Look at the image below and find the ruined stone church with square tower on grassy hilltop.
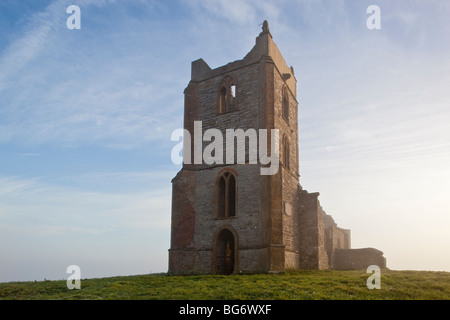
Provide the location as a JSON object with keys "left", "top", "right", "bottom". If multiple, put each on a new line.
{"left": 169, "top": 21, "right": 385, "bottom": 274}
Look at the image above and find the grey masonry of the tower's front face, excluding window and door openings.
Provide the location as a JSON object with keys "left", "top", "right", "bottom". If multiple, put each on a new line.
{"left": 186, "top": 58, "right": 270, "bottom": 273}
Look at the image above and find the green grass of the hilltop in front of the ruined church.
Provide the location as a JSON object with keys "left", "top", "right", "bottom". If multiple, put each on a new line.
{"left": 0, "top": 270, "right": 450, "bottom": 300}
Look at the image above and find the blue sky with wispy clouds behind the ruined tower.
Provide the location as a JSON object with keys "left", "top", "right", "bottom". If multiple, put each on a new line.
{"left": 0, "top": 0, "right": 450, "bottom": 281}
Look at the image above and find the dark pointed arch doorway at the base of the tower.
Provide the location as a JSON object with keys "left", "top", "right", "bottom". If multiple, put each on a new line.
{"left": 213, "top": 228, "right": 237, "bottom": 275}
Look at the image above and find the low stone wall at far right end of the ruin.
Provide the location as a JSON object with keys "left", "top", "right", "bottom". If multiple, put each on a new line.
{"left": 333, "top": 248, "right": 386, "bottom": 270}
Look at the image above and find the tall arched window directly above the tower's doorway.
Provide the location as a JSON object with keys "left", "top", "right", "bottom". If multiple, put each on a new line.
{"left": 216, "top": 171, "right": 237, "bottom": 218}
